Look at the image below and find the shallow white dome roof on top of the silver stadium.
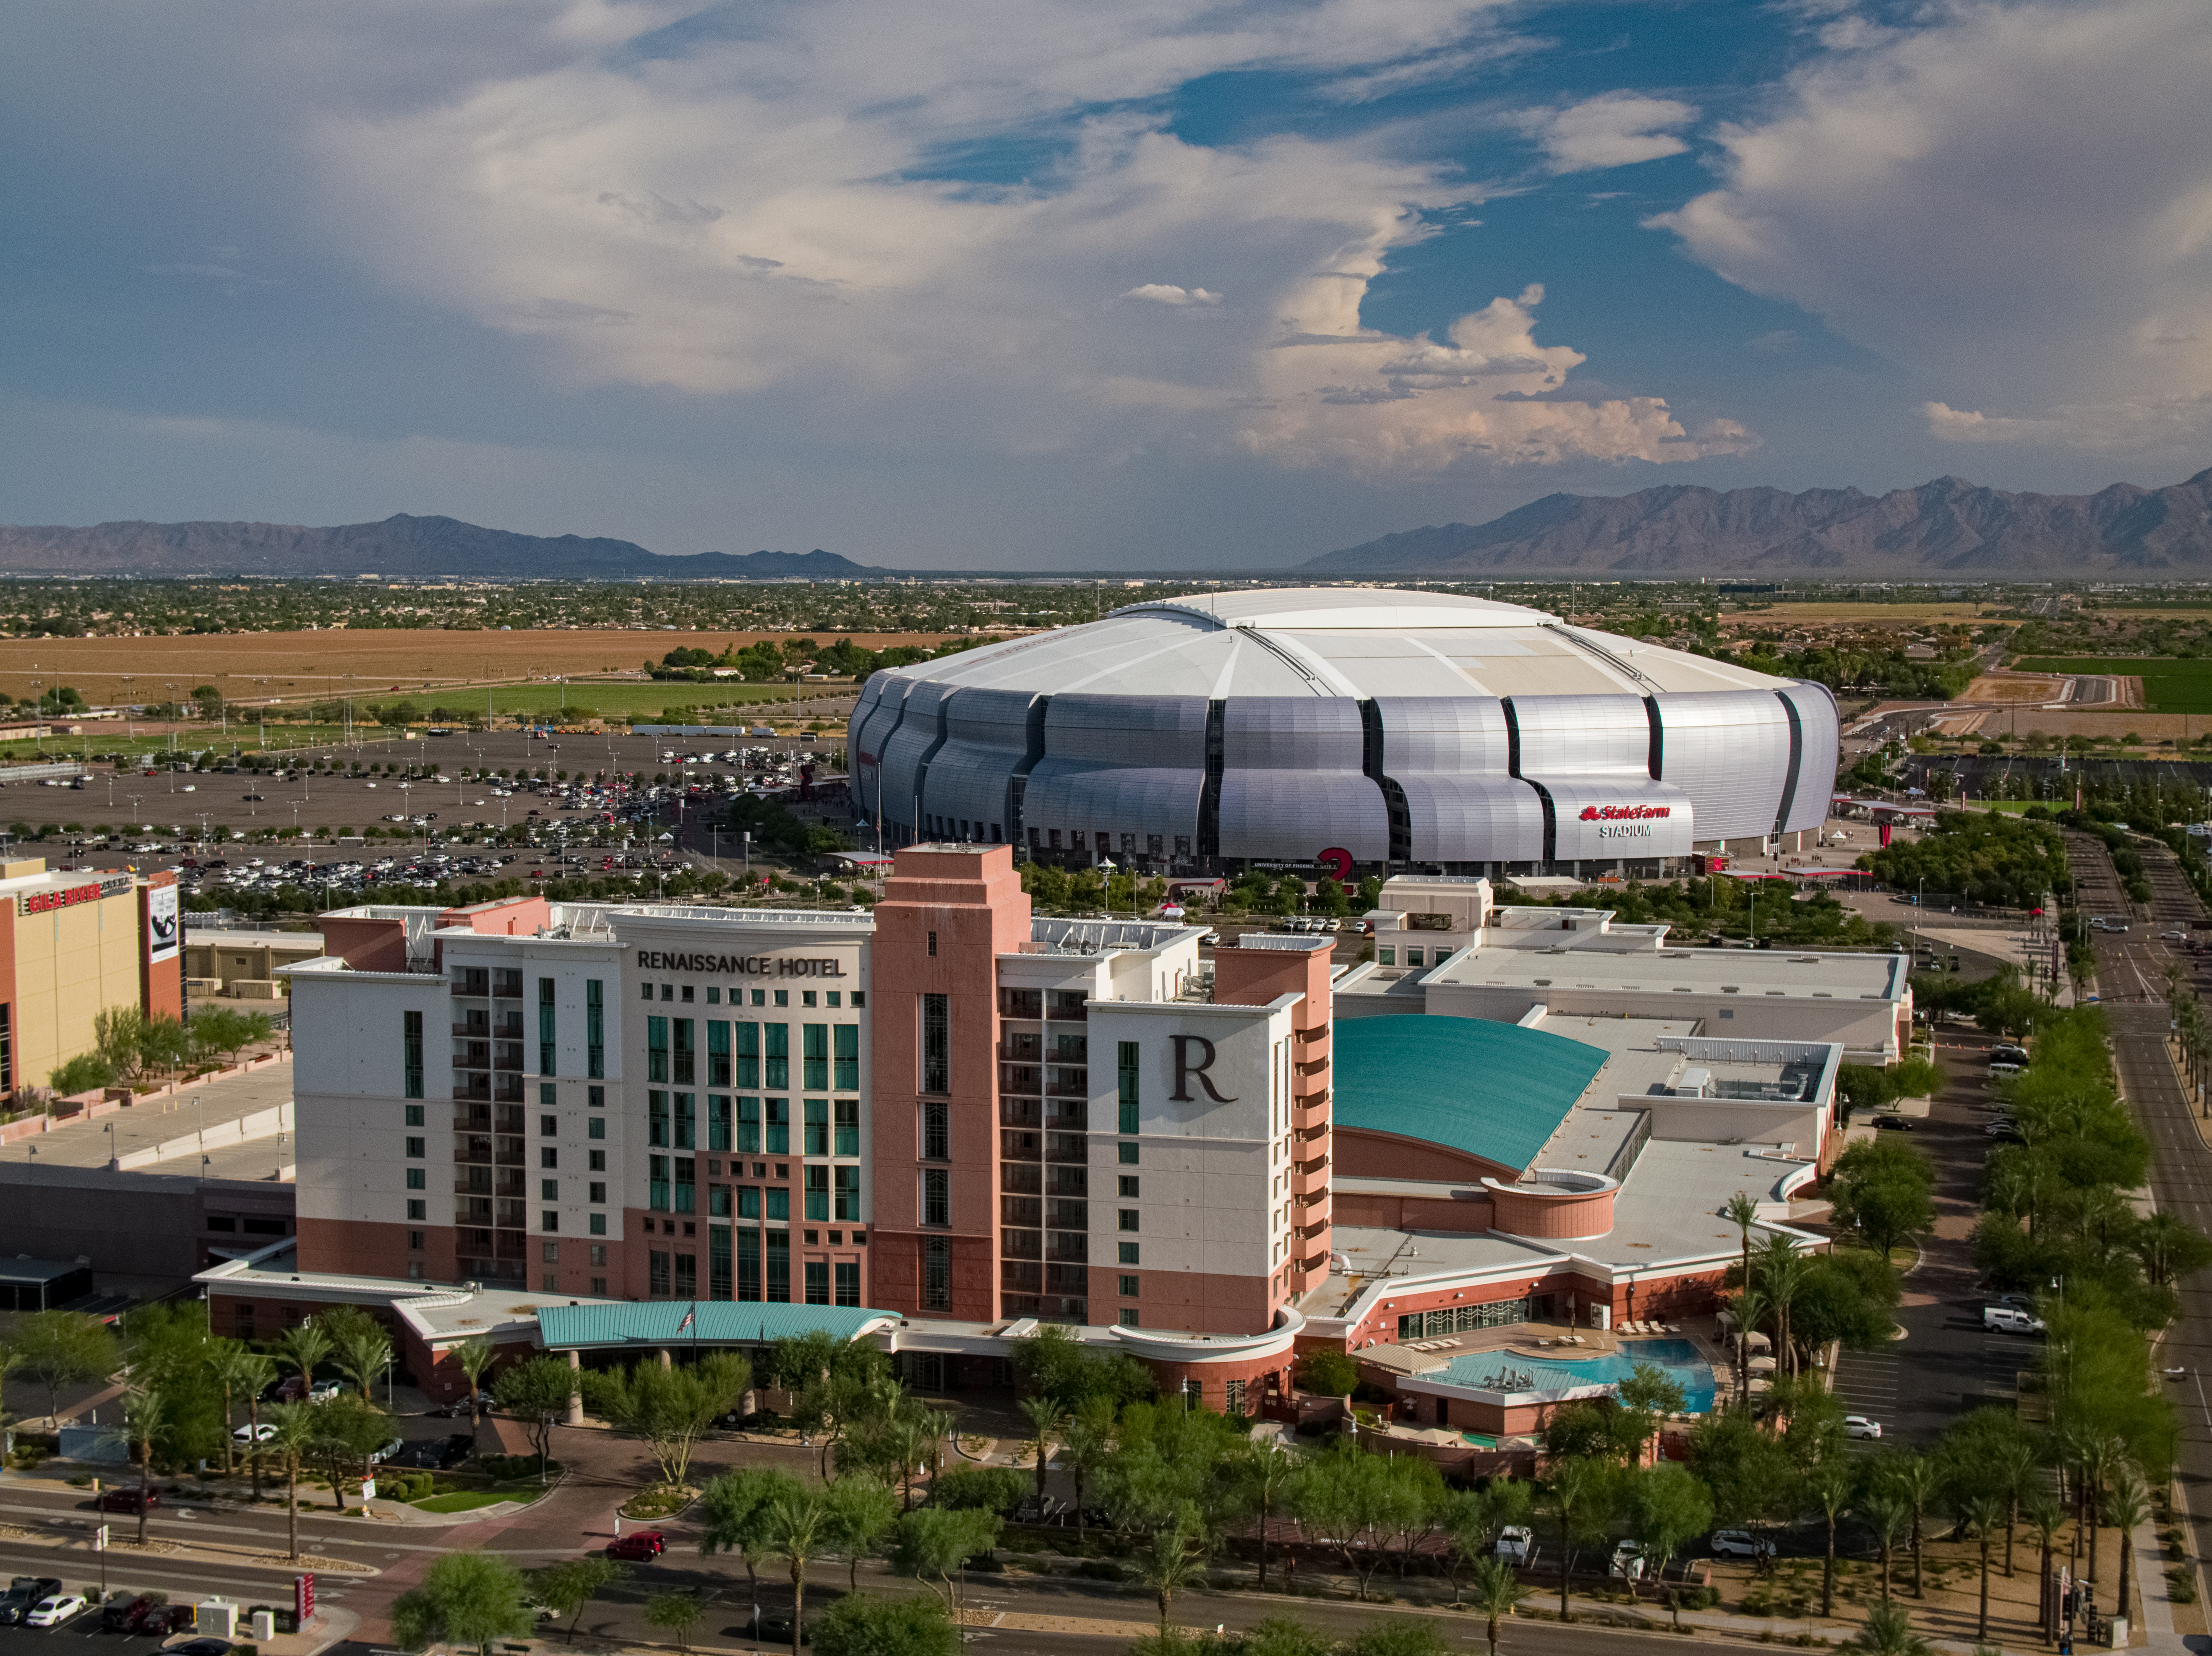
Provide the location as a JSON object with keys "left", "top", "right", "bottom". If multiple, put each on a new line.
{"left": 900, "top": 586, "right": 1787, "bottom": 701}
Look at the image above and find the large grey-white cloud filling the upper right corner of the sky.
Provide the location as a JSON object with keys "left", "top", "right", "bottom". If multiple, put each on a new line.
{"left": 1652, "top": 0, "right": 2212, "bottom": 460}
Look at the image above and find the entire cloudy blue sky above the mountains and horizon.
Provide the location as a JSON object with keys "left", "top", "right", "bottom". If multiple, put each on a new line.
{"left": 0, "top": 0, "right": 2212, "bottom": 568}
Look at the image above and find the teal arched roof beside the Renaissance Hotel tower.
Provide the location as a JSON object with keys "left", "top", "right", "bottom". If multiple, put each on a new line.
{"left": 1329, "top": 1017, "right": 1610, "bottom": 1172}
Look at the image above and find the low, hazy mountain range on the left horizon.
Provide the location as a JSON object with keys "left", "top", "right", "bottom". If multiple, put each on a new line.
{"left": 0, "top": 513, "right": 894, "bottom": 581}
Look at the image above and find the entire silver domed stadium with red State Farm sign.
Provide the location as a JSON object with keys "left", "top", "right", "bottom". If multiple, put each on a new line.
{"left": 847, "top": 588, "right": 1838, "bottom": 878}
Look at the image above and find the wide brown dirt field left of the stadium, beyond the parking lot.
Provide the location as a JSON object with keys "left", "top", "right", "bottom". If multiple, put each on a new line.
{"left": 0, "top": 628, "right": 969, "bottom": 705}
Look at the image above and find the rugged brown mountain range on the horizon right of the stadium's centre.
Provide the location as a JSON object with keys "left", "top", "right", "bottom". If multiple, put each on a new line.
{"left": 1299, "top": 469, "right": 2212, "bottom": 575}
